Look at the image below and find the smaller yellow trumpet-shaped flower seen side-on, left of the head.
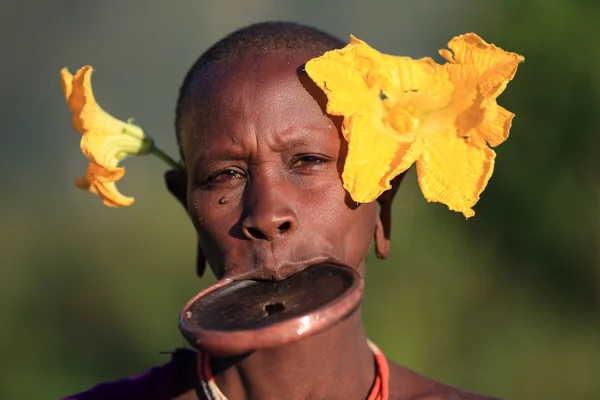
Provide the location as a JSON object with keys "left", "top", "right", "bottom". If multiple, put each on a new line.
{"left": 60, "top": 66, "right": 154, "bottom": 207}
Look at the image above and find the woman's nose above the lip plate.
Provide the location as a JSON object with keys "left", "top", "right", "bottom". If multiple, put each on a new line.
{"left": 242, "top": 181, "right": 298, "bottom": 242}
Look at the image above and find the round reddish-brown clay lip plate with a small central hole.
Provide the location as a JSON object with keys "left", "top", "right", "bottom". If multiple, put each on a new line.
{"left": 179, "top": 264, "right": 364, "bottom": 356}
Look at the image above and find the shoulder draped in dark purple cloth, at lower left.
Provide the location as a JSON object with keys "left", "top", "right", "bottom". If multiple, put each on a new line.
{"left": 63, "top": 349, "right": 198, "bottom": 400}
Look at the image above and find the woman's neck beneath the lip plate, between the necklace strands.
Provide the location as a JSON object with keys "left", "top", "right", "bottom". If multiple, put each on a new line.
{"left": 211, "top": 309, "right": 375, "bottom": 400}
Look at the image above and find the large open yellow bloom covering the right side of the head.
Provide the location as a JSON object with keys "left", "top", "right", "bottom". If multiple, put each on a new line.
{"left": 306, "top": 33, "right": 524, "bottom": 218}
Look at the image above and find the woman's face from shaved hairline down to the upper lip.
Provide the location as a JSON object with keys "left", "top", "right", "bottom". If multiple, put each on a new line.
{"left": 180, "top": 51, "right": 377, "bottom": 280}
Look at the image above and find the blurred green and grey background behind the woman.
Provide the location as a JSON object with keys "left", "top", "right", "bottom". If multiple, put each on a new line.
{"left": 0, "top": 0, "right": 600, "bottom": 400}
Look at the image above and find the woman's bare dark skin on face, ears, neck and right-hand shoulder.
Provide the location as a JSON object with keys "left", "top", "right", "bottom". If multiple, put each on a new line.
{"left": 166, "top": 51, "right": 496, "bottom": 400}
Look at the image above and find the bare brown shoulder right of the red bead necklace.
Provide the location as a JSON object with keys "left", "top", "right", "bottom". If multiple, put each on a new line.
{"left": 388, "top": 360, "right": 500, "bottom": 400}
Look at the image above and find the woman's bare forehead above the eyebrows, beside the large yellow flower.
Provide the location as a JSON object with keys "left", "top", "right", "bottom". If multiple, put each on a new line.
{"left": 179, "top": 51, "right": 331, "bottom": 159}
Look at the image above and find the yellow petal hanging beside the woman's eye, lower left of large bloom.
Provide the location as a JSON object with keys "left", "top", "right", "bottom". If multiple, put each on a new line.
{"left": 342, "top": 114, "right": 422, "bottom": 203}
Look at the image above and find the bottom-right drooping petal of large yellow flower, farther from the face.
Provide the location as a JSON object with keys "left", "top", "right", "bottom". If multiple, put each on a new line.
{"left": 417, "top": 130, "right": 496, "bottom": 218}
